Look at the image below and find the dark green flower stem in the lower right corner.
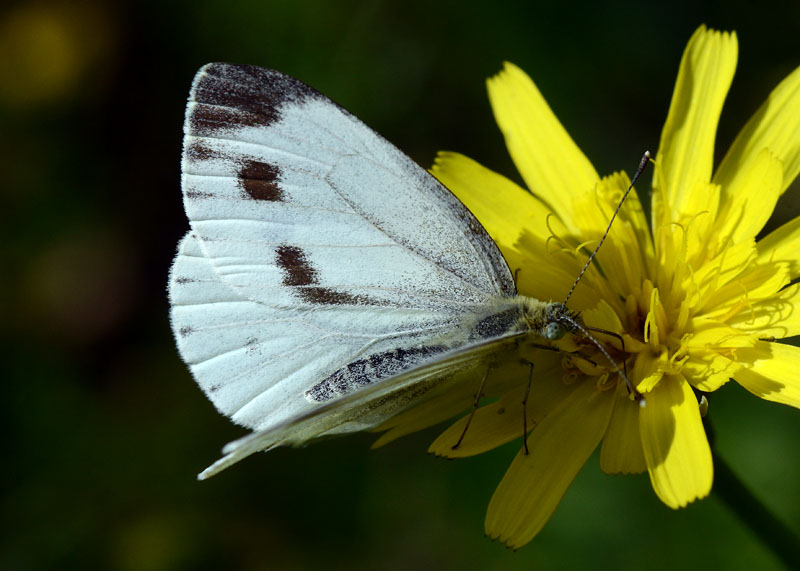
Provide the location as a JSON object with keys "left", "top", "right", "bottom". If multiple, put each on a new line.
{"left": 705, "top": 422, "right": 800, "bottom": 569}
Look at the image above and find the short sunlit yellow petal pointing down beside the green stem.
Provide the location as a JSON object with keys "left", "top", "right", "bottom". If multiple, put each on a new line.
{"left": 639, "top": 376, "right": 714, "bottom": 509}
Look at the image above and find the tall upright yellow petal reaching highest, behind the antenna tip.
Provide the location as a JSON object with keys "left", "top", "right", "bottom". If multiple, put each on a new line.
{"left": 654, "top": 26, "right": 738, "bottom": 227}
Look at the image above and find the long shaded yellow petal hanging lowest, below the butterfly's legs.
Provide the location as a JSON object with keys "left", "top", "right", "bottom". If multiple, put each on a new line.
{"left": 486, "top": 379, "right": 615, "bottom": 548}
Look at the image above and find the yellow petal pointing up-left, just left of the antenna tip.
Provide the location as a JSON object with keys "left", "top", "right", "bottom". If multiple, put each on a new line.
{"left": 487, "top": 63, "right": 600, "bottom": 230}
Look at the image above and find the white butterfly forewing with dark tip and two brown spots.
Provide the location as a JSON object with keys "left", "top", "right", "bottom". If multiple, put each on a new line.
{"left": 183, "top": 64, "right": 514, "bottom": 310}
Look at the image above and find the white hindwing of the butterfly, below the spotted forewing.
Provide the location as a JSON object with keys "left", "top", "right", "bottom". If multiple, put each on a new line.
{"left": 170, "top": 230, "right": 512, "bottom": 429}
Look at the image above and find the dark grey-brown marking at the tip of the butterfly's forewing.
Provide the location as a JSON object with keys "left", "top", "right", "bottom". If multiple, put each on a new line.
{"left": 187, "top": 63, "right": 321, "bottom": 135}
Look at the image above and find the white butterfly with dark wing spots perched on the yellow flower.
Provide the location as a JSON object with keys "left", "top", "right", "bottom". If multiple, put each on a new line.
{"left": 169, "top": 63, "right": 636, "bottom": 478}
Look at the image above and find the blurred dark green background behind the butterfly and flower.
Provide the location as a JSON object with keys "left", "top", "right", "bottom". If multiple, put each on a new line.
{"left": 0, "top": 0, "right": 800, "bottom": 571}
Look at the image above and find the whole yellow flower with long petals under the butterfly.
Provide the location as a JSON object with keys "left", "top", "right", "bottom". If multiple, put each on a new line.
{"left": 379, "top": 27, "right": 800, "bottom": 548}
